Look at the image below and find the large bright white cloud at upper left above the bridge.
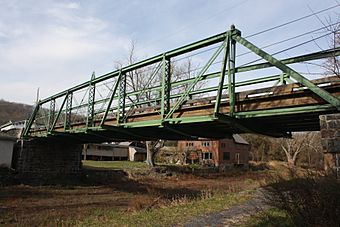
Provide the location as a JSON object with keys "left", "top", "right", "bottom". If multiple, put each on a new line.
{"left": 0, "top": 0, "right": 129, "bottom": 103}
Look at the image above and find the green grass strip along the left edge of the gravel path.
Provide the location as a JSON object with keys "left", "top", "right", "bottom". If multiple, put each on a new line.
{"left": 72, "top": 192, "right": 251, "bottom": 226}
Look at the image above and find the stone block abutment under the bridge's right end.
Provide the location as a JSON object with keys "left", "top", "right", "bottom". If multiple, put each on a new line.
{"left": 320, "top": 113, "right": 340, "bottom": 179}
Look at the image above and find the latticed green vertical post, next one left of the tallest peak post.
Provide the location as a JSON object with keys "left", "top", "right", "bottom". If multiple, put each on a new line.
{"left": 161, "top": 55, "right": 171, "bottom": 120}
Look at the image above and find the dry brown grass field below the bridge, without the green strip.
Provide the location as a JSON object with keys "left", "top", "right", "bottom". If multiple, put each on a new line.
{"left": 0, "top": 164, "right": 265, "bottom": 226}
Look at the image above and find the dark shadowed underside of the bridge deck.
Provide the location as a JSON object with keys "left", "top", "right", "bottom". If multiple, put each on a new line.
{"left": 31, "top": 110, "right": 336, "bottom": 143}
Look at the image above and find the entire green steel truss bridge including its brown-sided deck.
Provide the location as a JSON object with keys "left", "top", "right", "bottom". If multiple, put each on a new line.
{"left": 22, "top": 26, "right": 340, "bottom": 142}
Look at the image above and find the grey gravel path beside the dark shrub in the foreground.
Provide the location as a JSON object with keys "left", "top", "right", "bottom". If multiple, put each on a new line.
{"left": 184, "top": 190, "right": 267, "bottom": 227}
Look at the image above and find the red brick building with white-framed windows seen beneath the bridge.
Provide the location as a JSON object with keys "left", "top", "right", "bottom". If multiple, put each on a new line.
{"left": 177, "top": 134, "right": 249, "bottom": 169}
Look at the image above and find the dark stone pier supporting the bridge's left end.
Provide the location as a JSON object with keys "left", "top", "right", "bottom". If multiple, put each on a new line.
{"left": 16, "top": 140, "right": 83, "bottom": 179}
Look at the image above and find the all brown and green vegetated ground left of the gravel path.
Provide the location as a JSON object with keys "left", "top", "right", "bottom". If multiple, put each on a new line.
{"left": 0, "top": 161, "right": 265, "bottom": 226}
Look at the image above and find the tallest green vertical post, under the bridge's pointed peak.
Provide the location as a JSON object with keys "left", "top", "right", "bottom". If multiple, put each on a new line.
{"left": 228, "top": 25, "right": 236, "bottom": 116}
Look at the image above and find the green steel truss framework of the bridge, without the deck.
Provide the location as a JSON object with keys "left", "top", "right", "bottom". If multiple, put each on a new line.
{"left": 22, "top": 26, "right": 340, "bottom": 139}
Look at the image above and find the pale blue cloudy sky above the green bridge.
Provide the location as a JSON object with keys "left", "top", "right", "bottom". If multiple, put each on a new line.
{"left": 0, "top": 0, "right": 340, "bottom": 104}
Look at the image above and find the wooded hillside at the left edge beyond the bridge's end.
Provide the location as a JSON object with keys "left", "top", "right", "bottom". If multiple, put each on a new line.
{"left": 0, "top": 99, "right": 33, "bottom": 125}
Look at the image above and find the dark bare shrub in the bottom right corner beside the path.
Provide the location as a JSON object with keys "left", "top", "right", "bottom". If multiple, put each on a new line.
{"left": 264, "top": 174, "right": 340, "bottom": 226}
